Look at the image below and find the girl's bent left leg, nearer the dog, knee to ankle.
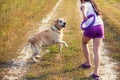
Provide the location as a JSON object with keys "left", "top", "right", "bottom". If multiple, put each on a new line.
{"left": 82, "top": 35, "right": 91, "bottom": 66}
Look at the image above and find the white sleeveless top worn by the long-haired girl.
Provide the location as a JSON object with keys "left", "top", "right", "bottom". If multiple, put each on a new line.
{"left": 81, "top": 2, "right": 103, "bottom": 26}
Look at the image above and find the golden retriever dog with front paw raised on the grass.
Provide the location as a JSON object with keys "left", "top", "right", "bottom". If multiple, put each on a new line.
{"left": 22, "top": 18, "right": 68, "bottom": 62}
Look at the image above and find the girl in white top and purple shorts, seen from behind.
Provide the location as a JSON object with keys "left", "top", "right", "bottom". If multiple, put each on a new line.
{"left": 80, "top": 0, "right": 104, "bottom": 80}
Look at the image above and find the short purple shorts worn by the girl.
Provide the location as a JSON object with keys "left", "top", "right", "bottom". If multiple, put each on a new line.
{"left": 83, "top": 25, "right": 104, "bottom": 38}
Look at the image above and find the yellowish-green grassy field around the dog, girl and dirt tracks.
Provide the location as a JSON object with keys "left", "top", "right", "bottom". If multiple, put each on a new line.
{"left": 0, "top": 0, "right": 120, "bottom": 80}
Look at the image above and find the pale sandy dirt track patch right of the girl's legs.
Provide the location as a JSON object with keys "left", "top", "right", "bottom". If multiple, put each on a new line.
{"left": 100, "top": 43, "right": 118, "bottom": 80}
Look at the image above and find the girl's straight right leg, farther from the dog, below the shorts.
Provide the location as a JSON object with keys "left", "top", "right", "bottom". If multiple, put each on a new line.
{"left": 93, "top": 38, "right": 102, "bottom": 75}
